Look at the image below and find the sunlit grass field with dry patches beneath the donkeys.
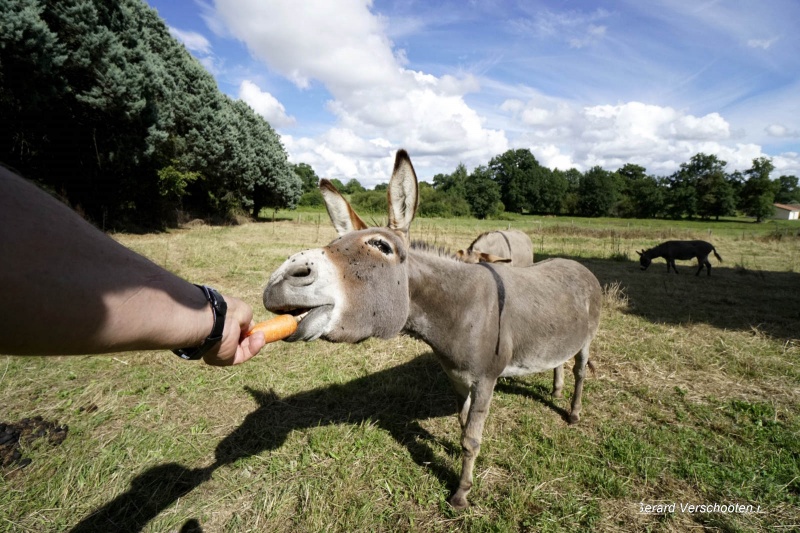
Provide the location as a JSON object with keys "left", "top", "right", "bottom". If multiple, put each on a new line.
{"left": 0, "top": 212, "right": 800, "bottom": 532}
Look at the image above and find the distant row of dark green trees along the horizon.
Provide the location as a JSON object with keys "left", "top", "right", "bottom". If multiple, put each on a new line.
{"left": 301, "top": 149, "right": 800, "bottom": 221}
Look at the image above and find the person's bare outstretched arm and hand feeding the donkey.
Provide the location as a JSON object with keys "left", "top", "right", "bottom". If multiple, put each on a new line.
{"left": 0, "top": 167, "right": 264, "bottom": 365}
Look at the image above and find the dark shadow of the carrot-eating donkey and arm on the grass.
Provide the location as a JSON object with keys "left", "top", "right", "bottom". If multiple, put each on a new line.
{"left": 71, "top": 353, "right": 562, "bottom": 532}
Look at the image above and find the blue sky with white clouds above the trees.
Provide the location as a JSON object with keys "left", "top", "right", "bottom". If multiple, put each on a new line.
{"left": 146, "top": 0, "right": 800, "bottom": 188}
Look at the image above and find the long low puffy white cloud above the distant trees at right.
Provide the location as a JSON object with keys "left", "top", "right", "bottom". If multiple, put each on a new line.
{"left": 501, "top": 96, "right": 764, "bottom": 175}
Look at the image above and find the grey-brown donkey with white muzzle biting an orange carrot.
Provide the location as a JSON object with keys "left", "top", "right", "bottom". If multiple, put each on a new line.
{"left": 264, "top": 150, "right": 601, "bottom": 508}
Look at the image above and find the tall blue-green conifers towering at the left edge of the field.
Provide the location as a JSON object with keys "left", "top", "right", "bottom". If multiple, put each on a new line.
{"left": 0, "top": 0, "right": 301, "bottom": 226}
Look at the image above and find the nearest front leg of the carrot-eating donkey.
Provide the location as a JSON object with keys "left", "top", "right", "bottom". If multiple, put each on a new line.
{"left": 448, "top": 379, "right": 497, "bottom": 509}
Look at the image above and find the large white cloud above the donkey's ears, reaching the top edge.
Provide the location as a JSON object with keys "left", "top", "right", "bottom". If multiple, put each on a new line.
{"left": 215, "top": 0, "right": 508, "bottom": 185}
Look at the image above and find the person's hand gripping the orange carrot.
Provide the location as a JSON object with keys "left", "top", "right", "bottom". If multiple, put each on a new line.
{"left": 203, "top": 295, "right": 265, "bottom": 366}
